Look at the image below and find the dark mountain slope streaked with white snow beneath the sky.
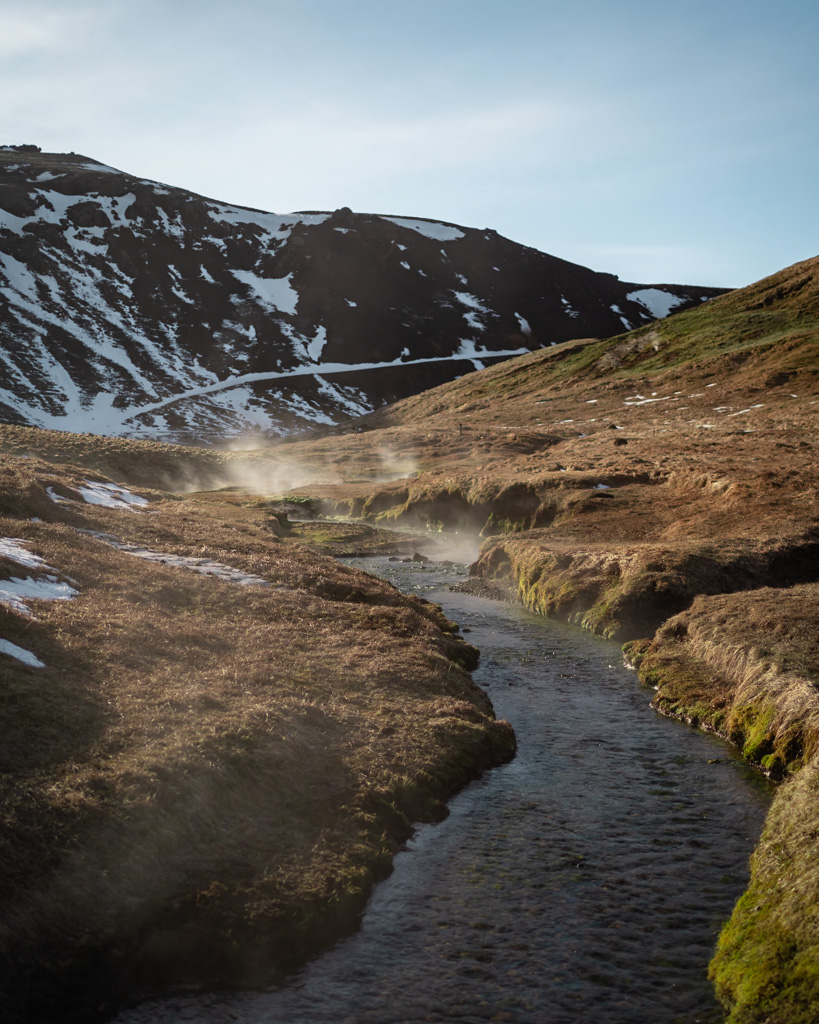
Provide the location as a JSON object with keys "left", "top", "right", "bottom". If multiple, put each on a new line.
{"left": 0, "top": 146, "right": 720, "bottom": 440}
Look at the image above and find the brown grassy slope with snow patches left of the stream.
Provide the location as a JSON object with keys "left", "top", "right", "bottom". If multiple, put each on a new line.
{"left": 0, "top": 450, "right": 514, "bottom": 1021}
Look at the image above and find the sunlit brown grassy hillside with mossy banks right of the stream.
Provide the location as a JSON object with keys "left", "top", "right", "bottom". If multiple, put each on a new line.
{"left": 257, "top": 259, "right": 819, "bottom": 1024}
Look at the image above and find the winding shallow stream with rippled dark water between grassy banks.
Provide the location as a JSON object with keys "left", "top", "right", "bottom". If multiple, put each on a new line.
{"left": 118, "top": 558, "right": 770, "bottom": 1024}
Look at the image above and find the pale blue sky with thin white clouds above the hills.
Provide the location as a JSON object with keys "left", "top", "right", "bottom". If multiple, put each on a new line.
{"left": 0, "top": 0, "right": 819, "bottom": 287}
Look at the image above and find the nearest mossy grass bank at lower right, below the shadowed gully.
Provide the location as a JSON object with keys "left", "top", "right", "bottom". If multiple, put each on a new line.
{"left": 634, "top": 584, "right": 819, "bottom": 1024}
